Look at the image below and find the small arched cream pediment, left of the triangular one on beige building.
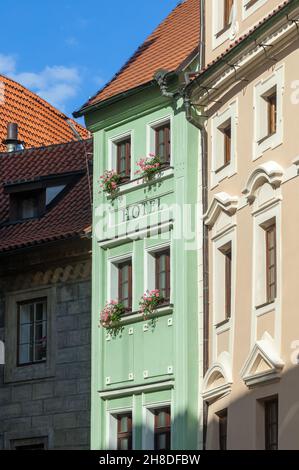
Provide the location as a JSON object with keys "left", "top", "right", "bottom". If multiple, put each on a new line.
{"left": 202, "top": 352, "right": 233, "bottom": 403}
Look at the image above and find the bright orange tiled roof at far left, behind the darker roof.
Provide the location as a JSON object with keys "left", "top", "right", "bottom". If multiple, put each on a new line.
{"left": 0, "top": 75, "right": 90, "bottom": 152}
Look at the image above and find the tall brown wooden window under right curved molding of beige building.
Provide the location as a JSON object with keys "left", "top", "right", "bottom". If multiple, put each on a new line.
{"left": 266, "top": 223, "right": 277, "bottom": 303}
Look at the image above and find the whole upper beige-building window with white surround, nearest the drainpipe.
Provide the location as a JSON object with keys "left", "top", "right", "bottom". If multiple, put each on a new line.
{"left": 211, "top": 102, "right": 237, "bottom": 187}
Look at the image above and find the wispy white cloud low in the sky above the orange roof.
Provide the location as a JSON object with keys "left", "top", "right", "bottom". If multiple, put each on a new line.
{"left": 0, "top": 54, "right": 81, "bottom": 111}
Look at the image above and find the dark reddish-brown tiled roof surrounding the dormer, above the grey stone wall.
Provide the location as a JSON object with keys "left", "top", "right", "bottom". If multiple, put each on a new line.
{"left": 0, "top": 140, "right": 92, "bottom": 252}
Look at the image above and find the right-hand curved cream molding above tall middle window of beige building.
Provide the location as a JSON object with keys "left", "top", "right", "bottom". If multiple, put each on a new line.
{"left": 242, "top": 161, "right": 284, "bottom": 204}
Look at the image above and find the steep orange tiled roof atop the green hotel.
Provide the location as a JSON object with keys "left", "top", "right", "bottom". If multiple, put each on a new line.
{"left": 78, "top": 0, "right": 200, "bottom": 113}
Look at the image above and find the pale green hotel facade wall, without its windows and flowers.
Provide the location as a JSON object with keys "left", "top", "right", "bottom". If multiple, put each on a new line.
{"left": 85, "top": 85, "right": 201, "bottom": 449}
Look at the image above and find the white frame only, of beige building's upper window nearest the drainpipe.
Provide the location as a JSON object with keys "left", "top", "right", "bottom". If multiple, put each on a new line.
{"left": 211, "top": 101, "right": 238, "bottom": 188}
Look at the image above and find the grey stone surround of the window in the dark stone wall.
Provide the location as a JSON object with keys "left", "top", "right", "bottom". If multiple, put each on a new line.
{"left": 4, "top": 287, "right": 56, "bottom": 383}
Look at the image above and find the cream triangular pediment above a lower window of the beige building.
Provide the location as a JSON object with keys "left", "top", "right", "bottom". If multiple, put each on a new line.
{"left": 241, "top": 332, "right": 284, "bottom": 388}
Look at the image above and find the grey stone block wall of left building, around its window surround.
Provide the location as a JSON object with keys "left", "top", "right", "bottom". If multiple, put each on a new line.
{"left": 0, "top": 280, "right": 91, "bottom": 450}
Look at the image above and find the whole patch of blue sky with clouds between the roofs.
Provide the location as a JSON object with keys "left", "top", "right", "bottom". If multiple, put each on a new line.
{"left": 0, "top": 0, "right": 179, "bottom": 119}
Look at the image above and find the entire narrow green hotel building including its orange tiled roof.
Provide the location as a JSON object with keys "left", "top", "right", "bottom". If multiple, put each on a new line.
{"left": 75, "top": 0, "right": 202, "bottom": 449}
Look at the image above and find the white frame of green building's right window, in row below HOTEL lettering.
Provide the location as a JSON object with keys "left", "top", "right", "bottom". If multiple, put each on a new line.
{"left": 144, "top": 240, "right": 173, "bottom": 303}
